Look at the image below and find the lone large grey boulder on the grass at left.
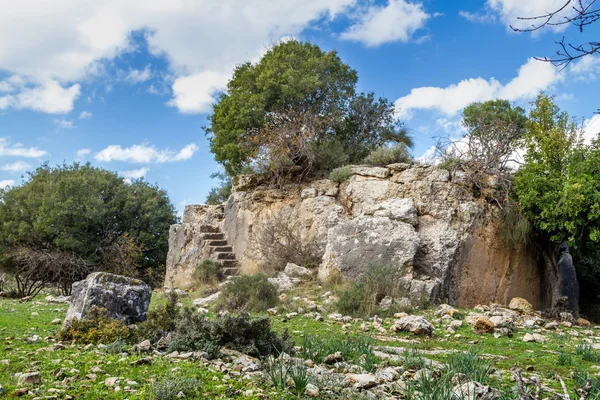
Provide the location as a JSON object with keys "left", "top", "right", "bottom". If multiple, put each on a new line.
{"left": 63, "top": 272, "right": 152, "bottom": 327}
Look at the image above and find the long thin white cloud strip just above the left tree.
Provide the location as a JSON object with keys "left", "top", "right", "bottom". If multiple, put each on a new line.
{"left": 94, "top": 143, "right": 198, "bottom": 164}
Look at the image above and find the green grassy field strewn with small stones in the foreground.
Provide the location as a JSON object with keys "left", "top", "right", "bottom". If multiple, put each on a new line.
{"left": 0, "top": 284, "right": 600, "bottom": 399}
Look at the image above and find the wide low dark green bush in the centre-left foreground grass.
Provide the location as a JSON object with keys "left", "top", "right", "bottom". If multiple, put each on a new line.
{"left": 169, "top": 308, "right": 293, "bottom": 357}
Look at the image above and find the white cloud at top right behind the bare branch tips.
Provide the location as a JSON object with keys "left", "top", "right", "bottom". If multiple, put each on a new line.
{"left": 486, "top": 0, "right": 572, "bottom": 32}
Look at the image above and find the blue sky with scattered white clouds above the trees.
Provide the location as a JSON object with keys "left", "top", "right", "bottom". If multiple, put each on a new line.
{"left": 0, "top": 0, "right": 600, "bottom": 214}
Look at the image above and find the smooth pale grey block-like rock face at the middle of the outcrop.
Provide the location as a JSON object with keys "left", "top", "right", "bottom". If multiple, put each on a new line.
{"left": 319, "top": 216, "right": 419, "bottom": 279}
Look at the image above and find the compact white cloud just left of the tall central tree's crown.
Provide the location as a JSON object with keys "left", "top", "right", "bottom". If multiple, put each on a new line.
{"left": 167, "top": 71, "right": 231, "bottom": 114}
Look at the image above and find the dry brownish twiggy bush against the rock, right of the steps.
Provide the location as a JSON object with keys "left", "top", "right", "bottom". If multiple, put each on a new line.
{"left": 249, "top": 210, "right": 323, "bottom": 271}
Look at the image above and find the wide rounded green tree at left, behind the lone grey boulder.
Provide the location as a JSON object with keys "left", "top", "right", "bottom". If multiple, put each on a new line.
{"left": 0, "top": 163, "right": 177, "bottom": 286}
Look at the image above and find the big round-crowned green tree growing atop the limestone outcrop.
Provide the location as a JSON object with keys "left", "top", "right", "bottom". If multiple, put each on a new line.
{"left": 207, "top": 40, "right": 410, "bottom": 184}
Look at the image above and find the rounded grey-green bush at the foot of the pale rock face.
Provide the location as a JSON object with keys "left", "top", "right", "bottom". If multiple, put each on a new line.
{"left": 336, "top": 265, "right": 406, "bottom": 317}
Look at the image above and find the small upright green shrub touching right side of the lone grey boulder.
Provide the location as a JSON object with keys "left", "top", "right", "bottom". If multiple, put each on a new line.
{"left": 135, "top": 290, "right": 180, "bottom": 343}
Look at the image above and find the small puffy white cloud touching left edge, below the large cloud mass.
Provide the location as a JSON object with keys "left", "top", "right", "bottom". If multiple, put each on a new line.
{"left": 0, "top": 79, "right": 81, "bottom": 114}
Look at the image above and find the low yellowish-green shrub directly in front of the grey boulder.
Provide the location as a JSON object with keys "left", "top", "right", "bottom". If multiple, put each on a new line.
{"left": 58, "top": 307, "right": 131, "bottom": 344}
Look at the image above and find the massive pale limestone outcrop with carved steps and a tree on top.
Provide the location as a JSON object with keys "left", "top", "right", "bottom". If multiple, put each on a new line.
{"left": 167, "top": 164, "right": 547, "bottom": 308}
